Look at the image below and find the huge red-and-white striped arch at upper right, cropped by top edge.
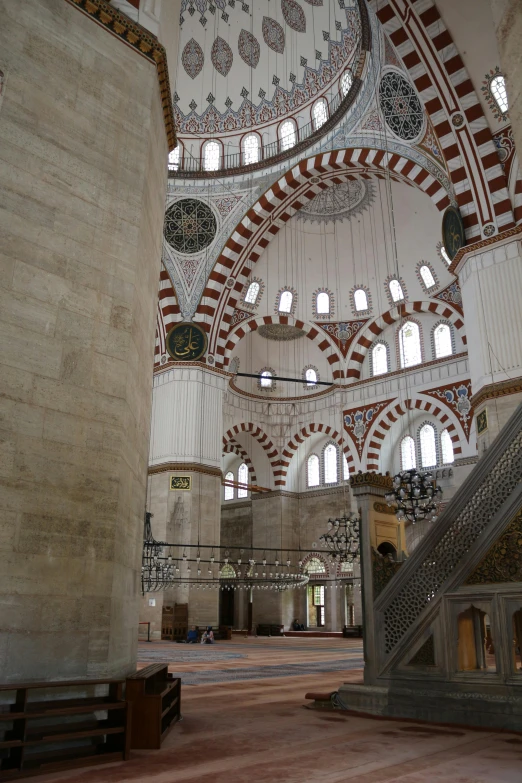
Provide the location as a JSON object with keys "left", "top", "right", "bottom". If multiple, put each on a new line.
{"left": 368, "top": 0, "right": 515, "bottom": 242}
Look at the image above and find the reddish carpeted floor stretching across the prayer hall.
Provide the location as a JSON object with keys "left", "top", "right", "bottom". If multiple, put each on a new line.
{"left": 39, "top": 638, "right": 522, "bottom": 783}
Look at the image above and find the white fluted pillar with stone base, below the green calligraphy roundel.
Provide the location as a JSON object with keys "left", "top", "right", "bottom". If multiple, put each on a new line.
{"left": 140, "top": 364, "right": 227, "bottom": 638}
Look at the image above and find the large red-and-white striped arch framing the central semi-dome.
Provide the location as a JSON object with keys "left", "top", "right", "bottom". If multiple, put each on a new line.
{"left": 196, "top": 148, "right": 450, "bottom": 361}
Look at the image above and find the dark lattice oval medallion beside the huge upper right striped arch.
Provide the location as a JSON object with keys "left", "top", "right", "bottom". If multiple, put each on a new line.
{"left": 379, "top": 71, "right": 424, "bottom": 141}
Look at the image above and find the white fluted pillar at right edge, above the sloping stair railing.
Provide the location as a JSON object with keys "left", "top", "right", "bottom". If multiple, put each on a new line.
{"left": 456, "top": 230, "right": 522, "bottom": 450}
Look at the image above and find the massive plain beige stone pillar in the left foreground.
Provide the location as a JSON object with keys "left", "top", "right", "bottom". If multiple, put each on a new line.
{"left": 0, "top": 0, "right": 168, "bottom": 682}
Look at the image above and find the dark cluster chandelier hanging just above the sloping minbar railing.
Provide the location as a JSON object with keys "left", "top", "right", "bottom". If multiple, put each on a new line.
{"left": 385, "top": 468, "right": 442, "bottom": 524}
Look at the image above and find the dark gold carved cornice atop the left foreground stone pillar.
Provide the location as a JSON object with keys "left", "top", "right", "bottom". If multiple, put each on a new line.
{"left": 65, "top": 0, "right": 177, "bottom": 150}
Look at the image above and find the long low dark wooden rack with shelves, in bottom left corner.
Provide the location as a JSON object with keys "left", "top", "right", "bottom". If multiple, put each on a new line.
{"left": 0, "top": 680, "right": 130, "bottom": 781}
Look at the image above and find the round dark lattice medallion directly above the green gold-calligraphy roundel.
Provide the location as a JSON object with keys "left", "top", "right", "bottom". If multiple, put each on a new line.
{"left": 163, "top": 198, "right": 217, "bottom": 254}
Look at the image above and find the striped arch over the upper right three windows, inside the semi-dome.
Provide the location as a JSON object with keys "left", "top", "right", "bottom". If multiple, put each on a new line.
{"left": 346, "top": 302, "right": 467, "bottom": 379}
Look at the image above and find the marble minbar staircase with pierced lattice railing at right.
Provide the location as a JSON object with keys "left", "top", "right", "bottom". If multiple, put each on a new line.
{"left": 333, "top": 406, "right": 522, "bottom": 731}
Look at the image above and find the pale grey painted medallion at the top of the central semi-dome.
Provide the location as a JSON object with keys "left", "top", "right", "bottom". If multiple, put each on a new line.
{"left": 296, "top": 179, "right": 375, "bottom": 223}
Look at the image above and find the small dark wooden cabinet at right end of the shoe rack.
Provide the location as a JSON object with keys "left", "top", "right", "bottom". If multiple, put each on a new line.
{"left": 126, "top": 663, "right": 181, "bottom": 749}
